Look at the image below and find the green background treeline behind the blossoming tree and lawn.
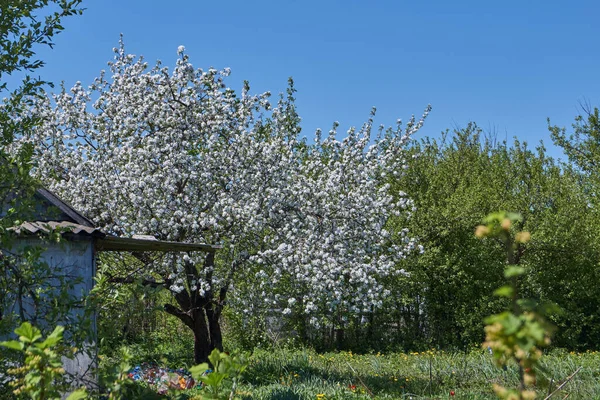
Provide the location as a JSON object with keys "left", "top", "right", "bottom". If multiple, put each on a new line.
{"left": 99, "top": 110, "right": 600, "bottom": 356}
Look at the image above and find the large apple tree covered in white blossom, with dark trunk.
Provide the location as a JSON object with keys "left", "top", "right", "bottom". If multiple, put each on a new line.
{"left": 18, "top": 43, "right": 429, "bottom": 362}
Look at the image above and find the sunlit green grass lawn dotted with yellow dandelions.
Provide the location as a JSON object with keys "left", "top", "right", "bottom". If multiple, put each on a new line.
{"left": 122, "top": 349, "right": 600, "bottom": 400}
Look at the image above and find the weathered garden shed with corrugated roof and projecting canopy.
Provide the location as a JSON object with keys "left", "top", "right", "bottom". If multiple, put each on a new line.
{"left": 0, "top": 188, "right": 220, "bottom": 384}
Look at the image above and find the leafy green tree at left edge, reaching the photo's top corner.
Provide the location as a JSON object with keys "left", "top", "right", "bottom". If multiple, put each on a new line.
{"left": 0, "top": 0, "right": 83, "bottom": 332}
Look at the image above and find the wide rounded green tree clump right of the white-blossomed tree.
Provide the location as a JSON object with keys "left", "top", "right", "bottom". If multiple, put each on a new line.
{"left": 379, "top": 124, "right": 599, "bottom": 347}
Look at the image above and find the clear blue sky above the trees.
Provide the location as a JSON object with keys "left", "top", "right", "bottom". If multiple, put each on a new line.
{"left": 16, "top": 0, "right": 600, "bottom": 161}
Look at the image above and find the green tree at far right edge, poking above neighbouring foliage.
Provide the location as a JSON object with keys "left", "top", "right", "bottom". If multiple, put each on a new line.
{"left": 546, "top": 104, "right": 600, "bottom": 349}
